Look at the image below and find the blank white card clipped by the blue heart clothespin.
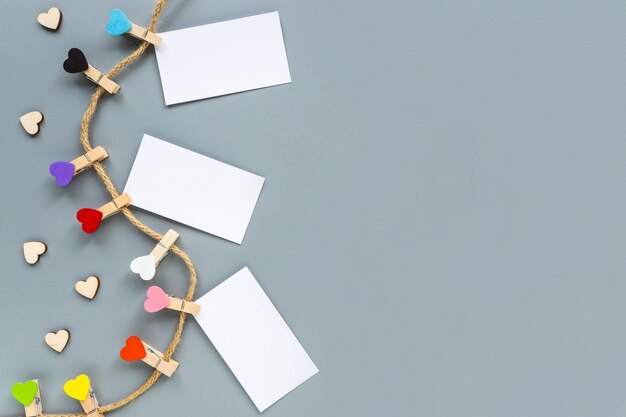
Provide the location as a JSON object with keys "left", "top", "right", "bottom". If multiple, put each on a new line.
{"left": 156, "top": 12, "right": 291, "bottom": 106}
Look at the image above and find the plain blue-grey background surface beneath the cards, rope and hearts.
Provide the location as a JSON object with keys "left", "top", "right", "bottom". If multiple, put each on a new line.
{"left": 0, "top": 0, "right": 626, "bottom": 417}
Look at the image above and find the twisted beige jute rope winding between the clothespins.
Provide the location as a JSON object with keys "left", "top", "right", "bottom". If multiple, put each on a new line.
{"left": 41, "top": 0, "right": 197, "bottom": 417}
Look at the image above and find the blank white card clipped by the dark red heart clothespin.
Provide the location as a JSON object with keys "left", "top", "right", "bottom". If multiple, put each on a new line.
{"left": 124, "top": 135, "right": 265, "bottom": 244}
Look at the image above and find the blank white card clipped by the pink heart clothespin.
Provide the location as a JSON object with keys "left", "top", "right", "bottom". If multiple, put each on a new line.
{"left": 196, "top": 268, "right": 318, "bottom": 412}
